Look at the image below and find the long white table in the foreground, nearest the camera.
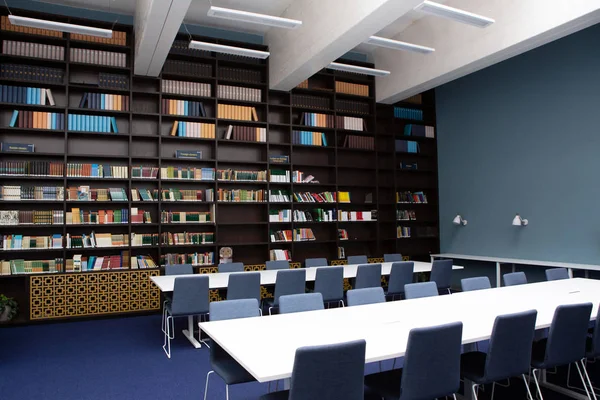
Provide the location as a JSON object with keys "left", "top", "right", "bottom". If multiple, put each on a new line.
{"left": 199, "top": 278, "right": 600, "bottom": 398}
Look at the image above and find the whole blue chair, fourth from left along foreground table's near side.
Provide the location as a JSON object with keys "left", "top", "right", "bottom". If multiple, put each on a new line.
{"left": 531, "top": 303, "right": 592, "bottom": 399}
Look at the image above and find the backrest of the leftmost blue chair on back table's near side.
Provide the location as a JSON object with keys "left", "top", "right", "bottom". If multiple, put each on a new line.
{"left": 171, "top": 275, "right": 209, "bottom": 316}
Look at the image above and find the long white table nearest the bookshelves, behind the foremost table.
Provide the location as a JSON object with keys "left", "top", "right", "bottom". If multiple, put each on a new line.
{"left": 150, "top": 261, "right": 463, "bottom": 349}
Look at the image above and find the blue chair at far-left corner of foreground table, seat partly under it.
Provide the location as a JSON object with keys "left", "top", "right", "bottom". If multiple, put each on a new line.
{"left": 204, "top": 299, "right": 260, "bottom": 400}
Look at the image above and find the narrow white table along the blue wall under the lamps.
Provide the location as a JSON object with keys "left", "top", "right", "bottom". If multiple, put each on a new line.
{"left": 431, "top": 253, "right": 600, "bottom": 287}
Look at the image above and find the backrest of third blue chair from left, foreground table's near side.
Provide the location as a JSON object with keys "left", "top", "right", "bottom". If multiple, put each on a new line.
{"left": 484, "top": 310, "right": 537, "bottom": 382}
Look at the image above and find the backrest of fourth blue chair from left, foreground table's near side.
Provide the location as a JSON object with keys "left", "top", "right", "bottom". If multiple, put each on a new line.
{"left": 544, "top": 303, "right": 592, "bottom": 368}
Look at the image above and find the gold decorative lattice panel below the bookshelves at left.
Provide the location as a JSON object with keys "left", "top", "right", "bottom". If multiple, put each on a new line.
{"left": 29, "top": 270, "right": 160, "bottom": 320}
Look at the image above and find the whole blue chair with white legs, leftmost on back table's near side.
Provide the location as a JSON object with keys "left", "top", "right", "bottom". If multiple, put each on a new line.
{"left": 163, "top": 275, "right": 209, "bottom": 358}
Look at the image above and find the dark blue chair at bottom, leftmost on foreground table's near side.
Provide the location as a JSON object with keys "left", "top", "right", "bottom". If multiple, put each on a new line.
{"left": 259, "top": 340, "right": 366, "bottom": 400}
